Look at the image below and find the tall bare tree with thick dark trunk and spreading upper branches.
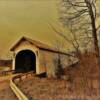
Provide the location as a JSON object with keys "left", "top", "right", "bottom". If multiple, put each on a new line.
{"left": 59, "top": 0, "right": 100, "bottom": 62}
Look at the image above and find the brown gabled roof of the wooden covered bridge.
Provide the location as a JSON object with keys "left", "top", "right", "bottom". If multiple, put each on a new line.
{"left": 10, "top": 37, "right": 72, "bottom": 56}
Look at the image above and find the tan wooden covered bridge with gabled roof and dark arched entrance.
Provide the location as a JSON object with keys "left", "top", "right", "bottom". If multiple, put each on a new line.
{"left": 11, "top": 37, "right": 75, "bottom": 77}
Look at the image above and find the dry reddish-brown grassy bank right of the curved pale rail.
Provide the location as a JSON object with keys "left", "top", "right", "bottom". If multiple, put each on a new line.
{"left": 18, "top": 54, "right": 100, "bottom": 100}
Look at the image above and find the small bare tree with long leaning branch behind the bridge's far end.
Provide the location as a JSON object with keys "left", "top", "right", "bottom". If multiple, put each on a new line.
{"left": 49, "top": 23, "right": 88, "bottom": 59}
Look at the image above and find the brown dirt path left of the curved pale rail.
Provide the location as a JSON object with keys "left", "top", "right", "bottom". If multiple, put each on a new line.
{"left": 0, "top": 77, "right": 18, "bottom": 100}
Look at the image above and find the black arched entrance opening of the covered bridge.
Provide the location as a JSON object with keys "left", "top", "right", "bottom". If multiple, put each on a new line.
{"left": 15, "top": 50, "right": 36, "bottom": 73}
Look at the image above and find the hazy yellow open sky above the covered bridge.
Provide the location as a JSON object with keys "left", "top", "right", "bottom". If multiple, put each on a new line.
{"left": 0, "top": 0, "right": 72, "bottom": 57}
